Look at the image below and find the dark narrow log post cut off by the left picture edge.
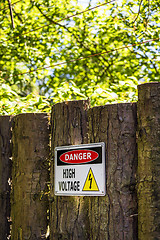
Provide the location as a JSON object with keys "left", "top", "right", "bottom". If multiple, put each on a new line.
{"left": 0, "top": 116, "right": 11, "bottom": 239}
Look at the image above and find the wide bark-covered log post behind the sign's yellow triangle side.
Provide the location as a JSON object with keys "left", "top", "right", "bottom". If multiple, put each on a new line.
{"left": 88, "top": 103, "right": 137, "bottom": 240}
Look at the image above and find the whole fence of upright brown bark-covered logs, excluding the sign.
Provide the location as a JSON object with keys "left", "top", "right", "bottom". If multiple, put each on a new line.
{"left": 0, "top": 83, "right": 160, "bottom": 240}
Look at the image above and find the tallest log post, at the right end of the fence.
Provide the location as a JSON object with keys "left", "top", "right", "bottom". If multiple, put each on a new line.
{"left": 138, "top": 83, "right": 160, "bottom": 240}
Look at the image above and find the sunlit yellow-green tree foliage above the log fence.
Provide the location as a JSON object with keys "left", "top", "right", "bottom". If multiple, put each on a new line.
{"left": 0, "top": 0, "right": 160, "bottom": 114}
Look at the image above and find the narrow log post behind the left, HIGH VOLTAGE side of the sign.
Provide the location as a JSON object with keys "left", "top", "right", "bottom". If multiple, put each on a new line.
{"left": 50, "top": 101, "right": 88, "bottom": 240}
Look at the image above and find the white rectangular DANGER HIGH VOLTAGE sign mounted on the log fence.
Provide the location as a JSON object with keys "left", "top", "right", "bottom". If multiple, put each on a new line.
{"left": 54, "top": 142, "right": 106, "bottom": 196}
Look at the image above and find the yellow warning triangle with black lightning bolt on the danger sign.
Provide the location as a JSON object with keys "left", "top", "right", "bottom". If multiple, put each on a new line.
{"left": 82, "top": 168, "right": 99, "bottom": 191}
